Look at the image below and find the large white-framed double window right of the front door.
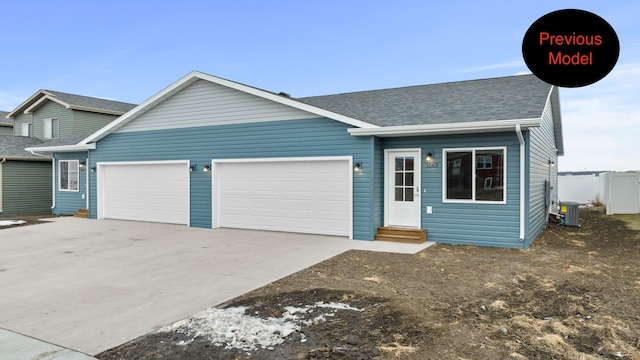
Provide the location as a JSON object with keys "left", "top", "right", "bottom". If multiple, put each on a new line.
{"left": 442, "top": 148, "right": 506, "bottom": 203}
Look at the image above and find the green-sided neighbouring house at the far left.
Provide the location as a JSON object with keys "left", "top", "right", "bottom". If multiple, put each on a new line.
{"left": 0, "top": 90, "right": 135, "bottom": 216}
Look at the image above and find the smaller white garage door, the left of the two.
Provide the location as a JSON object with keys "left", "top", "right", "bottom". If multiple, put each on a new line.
{"left": 98, "top": 162, "right": 189, "bottom": 225}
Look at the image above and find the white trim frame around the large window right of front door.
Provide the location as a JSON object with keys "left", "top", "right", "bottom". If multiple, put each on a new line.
{"left": 442, "top": 146, "right": 508, "bottom": 205}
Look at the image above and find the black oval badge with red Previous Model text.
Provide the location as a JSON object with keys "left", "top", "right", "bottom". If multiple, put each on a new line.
{"left": 522, "top": 9, "right": 620, "bottom": 87}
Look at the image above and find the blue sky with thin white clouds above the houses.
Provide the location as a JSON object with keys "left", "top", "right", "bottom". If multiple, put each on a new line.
{"left": 0, "top": 0, "right": 640, "bottom": 171}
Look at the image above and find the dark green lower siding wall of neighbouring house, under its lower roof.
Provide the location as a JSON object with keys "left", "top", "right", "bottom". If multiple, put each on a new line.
{"left": 2, "top": 160, "right": 52, "bottom": 215}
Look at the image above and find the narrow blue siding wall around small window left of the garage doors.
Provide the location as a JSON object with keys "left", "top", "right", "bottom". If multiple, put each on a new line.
{"left": 53, "top": 152, "right": 87, "bottom": 215}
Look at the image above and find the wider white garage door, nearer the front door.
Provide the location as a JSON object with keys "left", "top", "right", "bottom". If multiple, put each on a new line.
{"left": 218, "top": 160, "right": 351, "bottom": 236}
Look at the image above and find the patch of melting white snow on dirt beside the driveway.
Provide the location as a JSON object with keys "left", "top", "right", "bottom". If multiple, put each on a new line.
{"left": 159, "top": 302, "right": 364, "bottom": 351}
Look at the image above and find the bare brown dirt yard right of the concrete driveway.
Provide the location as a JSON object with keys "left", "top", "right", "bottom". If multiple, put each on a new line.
{"left": 98, "top": 209, "right": 640, "bottom": 360}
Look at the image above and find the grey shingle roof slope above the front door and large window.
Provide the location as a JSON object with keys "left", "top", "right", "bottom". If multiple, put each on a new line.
{"left": 296, "top": 75, "right": 551, "bottom": 126}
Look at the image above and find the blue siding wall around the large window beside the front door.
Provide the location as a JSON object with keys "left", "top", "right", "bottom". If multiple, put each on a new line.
{"left": 376, "top": 133, "right": 524, "bottom": 248}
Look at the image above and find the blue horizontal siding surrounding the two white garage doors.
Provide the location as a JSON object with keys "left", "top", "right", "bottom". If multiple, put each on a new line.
{"left": 89, "top": 118, "right": 374, "bottom": 240}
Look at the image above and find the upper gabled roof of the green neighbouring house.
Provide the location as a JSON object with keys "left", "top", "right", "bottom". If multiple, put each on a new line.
{"left": 7, "top": 90, "right": 136, "bottom": 118}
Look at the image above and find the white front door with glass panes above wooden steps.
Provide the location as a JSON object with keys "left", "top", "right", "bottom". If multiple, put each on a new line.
{"left": 385, "top": 149, "right": 420, "bottom": 228}
